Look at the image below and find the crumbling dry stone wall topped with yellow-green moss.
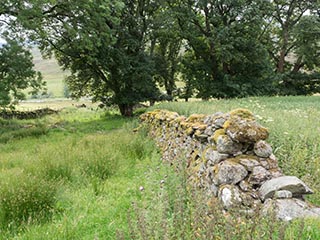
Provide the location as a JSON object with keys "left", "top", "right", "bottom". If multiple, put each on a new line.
{"left": 140, "top": 109, "right": 320, "bottom": 220}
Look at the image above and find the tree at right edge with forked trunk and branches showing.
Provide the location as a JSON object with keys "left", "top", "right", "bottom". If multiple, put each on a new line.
{"left": 261, "top": 0, "right": 320, "bottom": 95}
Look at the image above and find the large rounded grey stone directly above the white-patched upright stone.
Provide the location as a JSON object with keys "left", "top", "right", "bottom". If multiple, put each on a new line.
{"left": 214, "top": 160, "right": 248, "bottom": 185}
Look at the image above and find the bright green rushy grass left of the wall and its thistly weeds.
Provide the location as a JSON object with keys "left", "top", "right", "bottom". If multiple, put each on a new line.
{"left": 0, "top": 109, "right": 165, "bottom": 239}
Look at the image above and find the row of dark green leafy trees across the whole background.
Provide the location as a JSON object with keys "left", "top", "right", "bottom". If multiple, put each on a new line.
{"left": 0, "top": 0, "right": 320, "bottom": 116}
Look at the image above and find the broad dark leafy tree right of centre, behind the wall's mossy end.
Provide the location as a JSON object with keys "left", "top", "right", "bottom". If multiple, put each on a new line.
{"left": 171, "top": 0, "right": 272, "bottom": 99}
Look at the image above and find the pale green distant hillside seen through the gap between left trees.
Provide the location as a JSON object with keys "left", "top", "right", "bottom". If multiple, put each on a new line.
{"left": 32, "top": 48, "right": 68, "bottom": 98}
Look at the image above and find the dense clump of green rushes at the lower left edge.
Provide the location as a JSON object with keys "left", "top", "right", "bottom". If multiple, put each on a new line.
{"left": 0, "top": 169, "right": 57, "bottom": 228}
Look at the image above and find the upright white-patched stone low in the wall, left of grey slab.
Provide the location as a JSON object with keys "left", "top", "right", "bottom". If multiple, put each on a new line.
{"left": 218, "top": 185, "right": 242, "bottom": 209}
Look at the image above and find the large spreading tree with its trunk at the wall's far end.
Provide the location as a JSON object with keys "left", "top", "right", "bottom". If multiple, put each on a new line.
{"left": 16, "top": 0, "right": 159, "bottom": 116}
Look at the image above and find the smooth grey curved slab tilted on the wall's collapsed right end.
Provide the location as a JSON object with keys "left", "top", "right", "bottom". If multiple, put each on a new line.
{"left": 259, "top": 176, "right": 313, "bottom": 201}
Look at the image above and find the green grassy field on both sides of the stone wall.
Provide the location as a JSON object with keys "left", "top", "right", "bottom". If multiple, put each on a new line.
{"left": 0, "top": 96, "right": 320, "bottom": 240}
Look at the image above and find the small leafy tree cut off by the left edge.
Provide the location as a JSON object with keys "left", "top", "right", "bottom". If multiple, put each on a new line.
{"left": 0, "top": 39, "right": 44, "bottom": 106}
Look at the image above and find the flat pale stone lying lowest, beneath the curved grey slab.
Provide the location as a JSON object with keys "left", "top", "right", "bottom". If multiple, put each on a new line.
{"left": 262, "top": 198, "right": 320, "bottom": 221}
